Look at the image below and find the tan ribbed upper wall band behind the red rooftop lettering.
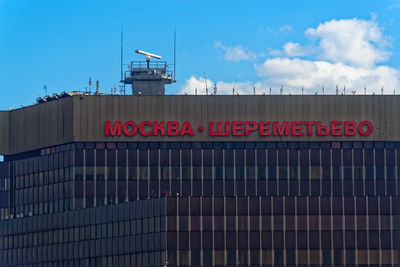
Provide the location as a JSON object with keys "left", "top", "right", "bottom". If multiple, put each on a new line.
{"left": 0, "top": 95, "right": 400, "bottom": 154}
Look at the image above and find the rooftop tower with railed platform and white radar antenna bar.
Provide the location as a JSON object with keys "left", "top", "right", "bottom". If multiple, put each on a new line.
{"left": 121, "top": 50, "right": 176, "bottom": 95}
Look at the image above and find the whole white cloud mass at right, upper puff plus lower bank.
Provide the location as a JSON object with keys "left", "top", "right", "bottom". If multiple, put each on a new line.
{"left": 255, "top": 17, "right": 400, "bottom": 93}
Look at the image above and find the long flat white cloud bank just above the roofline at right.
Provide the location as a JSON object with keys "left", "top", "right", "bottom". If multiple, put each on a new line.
{"left": 255, "top": 58, "right": 400, "bottom": 94}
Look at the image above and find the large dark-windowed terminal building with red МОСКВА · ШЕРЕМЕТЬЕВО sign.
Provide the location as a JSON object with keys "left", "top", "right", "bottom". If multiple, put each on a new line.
{"left": 0, "top": 95, "right": 400, "bottom": 267}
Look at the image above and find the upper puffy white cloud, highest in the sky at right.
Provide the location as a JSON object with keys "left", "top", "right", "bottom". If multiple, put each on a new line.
{"left": 306, "top": 18, "right": 390, "bottom": 67}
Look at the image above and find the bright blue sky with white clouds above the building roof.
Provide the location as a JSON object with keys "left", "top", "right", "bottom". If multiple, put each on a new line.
{"left": 0, "top": 0, "right": 400, "bottom": 110}
